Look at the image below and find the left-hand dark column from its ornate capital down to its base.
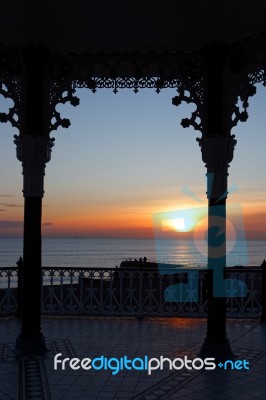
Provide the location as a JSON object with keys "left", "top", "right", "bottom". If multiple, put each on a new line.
{"left": 15, "top": 135, "right": 53, "bottom": 355}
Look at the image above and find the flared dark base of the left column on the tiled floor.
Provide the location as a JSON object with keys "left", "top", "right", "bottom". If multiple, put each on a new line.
{"left": 15, "top": 336, "right": 48, "bottom": 357}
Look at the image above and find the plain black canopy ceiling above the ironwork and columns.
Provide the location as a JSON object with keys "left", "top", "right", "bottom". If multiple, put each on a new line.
{"left": 0, "top": 0, "right": 266, "bottom": 53}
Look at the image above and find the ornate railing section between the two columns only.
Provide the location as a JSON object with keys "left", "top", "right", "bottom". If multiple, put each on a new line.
{"left": 40, "top": 268, "right": 206, "bottom": 317}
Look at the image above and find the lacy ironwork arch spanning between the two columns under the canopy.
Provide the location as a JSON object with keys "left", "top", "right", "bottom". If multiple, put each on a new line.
{"left": 49, "top": 54, "right": 204, "bottom": 134}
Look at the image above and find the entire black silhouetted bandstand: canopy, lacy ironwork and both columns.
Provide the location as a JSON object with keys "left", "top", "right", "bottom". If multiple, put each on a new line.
{"left": 0, "top": 0, "right": 266, "bottom": 356}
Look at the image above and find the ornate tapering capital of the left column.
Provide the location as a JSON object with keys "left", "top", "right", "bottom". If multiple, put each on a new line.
{"left": 14, "top": 135, "right": 54, "bottom": 197}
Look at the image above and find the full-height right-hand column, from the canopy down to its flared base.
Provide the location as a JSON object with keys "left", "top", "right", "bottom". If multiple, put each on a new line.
{"left": 198, "top": 44, "right": 236, "bottom": 360}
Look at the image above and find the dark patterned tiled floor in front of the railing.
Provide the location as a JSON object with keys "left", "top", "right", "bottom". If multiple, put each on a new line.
{"left": 0, "top": 317, "right": 266, "bottom": 400}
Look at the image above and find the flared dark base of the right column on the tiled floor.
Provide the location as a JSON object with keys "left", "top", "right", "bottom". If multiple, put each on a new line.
{"left": 199, "top": 338, "right": 236, "bottom": 362}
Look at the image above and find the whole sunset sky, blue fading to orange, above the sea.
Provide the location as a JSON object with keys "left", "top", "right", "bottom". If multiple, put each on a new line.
{"left": 0, "top": 85, "right": 266, "bottom": 240}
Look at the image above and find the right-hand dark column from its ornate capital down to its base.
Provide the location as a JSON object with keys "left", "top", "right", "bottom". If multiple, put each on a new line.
{"left": 199, "top": 137, "right": 236, "bottom": 359}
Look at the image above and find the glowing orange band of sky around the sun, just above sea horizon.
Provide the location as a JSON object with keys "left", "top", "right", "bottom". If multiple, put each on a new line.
{"left": 0, "top": 189, "right": 266, "bottom": 240}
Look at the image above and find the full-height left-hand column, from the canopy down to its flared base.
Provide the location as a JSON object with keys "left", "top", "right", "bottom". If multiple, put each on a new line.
{"left": 15, "top": 48, "right": 53, "bottom": 355}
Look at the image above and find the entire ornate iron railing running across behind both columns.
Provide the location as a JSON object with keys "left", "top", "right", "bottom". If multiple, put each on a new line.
{"left": 0, "top": 267, "right": 262, "bottom": 318}
